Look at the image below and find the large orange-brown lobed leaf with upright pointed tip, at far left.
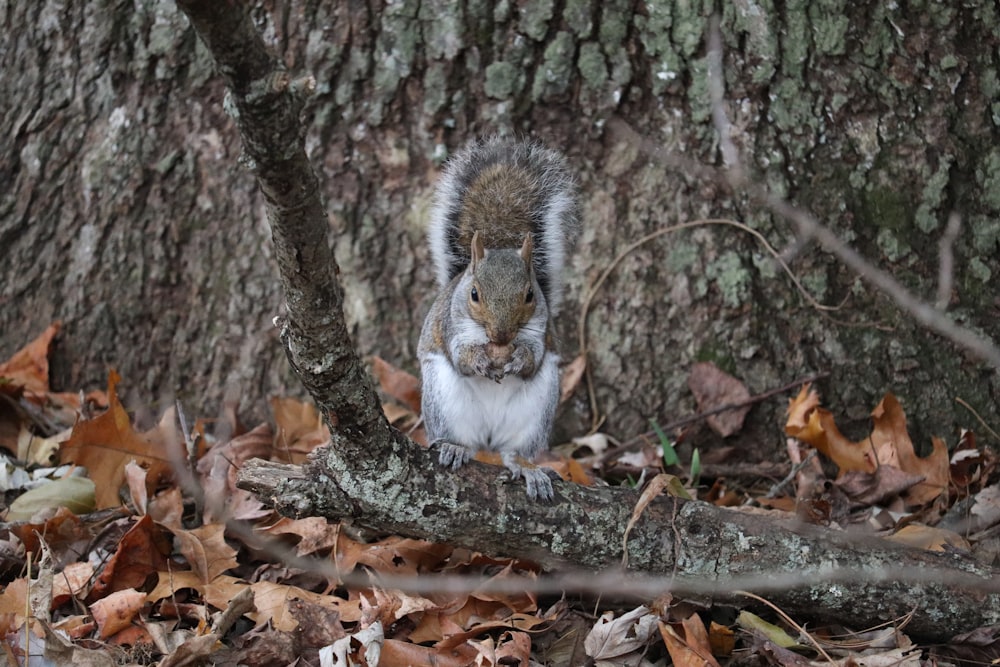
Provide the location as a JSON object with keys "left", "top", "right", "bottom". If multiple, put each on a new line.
{"left": 59, "top": 370, "right": 186, "bottom": 509}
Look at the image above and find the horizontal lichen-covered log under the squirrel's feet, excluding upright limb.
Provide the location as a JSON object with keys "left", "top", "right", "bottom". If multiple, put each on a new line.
{"left": 240, "top": 448, "right": 1000, "bottom": 641}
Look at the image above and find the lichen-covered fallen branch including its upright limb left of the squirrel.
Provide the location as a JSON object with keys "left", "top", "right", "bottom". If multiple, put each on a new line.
{"left": 166, "top": 0, "right": 1000, "bottom": 639}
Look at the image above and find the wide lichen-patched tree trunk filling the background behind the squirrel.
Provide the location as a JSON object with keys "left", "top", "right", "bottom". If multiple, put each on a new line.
{"left": 0, "top": 0, "right": 1000, "bottom": 457}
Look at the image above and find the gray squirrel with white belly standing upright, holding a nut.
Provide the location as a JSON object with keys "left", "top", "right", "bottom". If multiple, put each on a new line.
{"left": 417, "top": 137, "right": 580, "bottom": 500}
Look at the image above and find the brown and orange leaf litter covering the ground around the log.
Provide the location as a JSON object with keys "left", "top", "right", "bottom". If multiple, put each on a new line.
{"left": 0, "top": 324, "right": 1000, "bottom": 667}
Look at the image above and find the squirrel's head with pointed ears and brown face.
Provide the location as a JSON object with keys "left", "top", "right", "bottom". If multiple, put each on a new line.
{"left": 466, "top": 232, "right": 545, "bottom": 345}
